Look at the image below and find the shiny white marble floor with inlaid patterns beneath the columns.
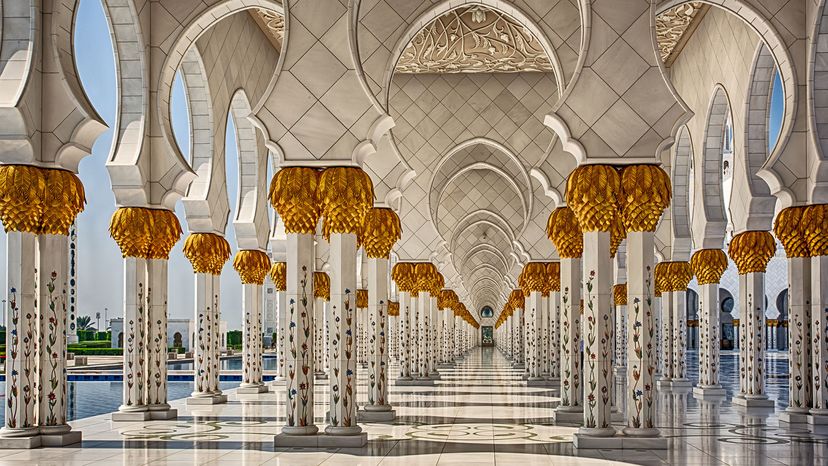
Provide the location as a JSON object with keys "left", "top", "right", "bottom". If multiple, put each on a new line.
{"left": 0, "top": 348, "right": 828, "bottom": 466}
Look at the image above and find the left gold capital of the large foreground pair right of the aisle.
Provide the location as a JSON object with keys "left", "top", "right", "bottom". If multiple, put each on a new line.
{"left": 566, "top": 164, "right": 621, "bottom": 232}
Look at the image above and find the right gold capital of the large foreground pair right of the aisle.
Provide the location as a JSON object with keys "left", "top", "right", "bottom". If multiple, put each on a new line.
{"left": 619, "top": 165, "right": 673, "bottom": 231}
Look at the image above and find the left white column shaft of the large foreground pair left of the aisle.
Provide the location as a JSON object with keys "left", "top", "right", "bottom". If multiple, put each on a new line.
{"left": 282, "top": 233, "right": 319, "bottom": 435}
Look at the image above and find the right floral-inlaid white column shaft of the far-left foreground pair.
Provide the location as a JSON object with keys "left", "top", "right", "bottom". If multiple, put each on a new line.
{"left": 36, "top": 234, "right": 72, "bottom": 443}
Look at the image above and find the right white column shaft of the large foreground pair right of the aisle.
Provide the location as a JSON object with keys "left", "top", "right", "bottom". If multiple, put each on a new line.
{"left": 624, "top": 231, "right": 659, "bottom": 437}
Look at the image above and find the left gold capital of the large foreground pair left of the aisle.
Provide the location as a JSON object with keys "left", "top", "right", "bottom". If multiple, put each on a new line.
{"left": 269, "top": 167, "right": 321, "bottom": 234}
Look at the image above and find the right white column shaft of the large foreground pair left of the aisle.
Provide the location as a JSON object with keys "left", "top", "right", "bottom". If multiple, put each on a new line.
{"left": 325, "top": 233, "right": 360, "bottom": 441}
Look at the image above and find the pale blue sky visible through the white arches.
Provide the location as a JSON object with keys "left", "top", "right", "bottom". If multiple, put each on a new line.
{"left": 0, "top": 0, "right": 784, "bottom": 329}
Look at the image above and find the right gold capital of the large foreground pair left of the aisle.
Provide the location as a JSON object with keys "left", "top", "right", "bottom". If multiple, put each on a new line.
{"left": 316, "top": 167, "right": 374, "bottom": 239}
